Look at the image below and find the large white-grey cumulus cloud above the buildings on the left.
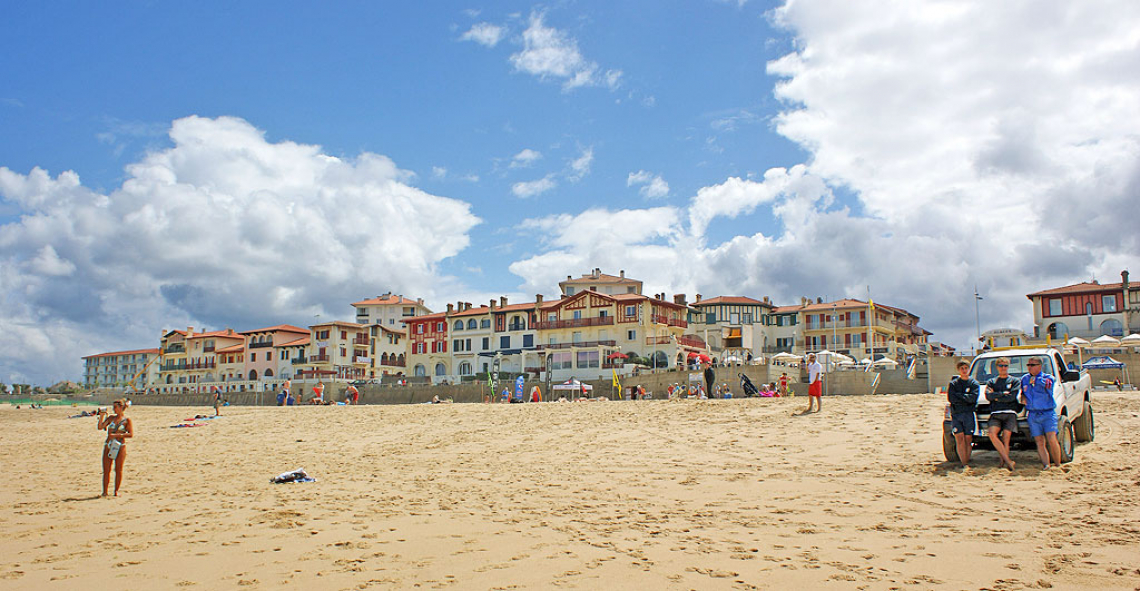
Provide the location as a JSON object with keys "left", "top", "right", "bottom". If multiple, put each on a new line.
{"left": 0, "top": 116, "right": 480, "bottom": 381}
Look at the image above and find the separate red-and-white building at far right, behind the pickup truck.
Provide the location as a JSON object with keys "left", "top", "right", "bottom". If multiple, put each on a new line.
{"left": 1026, "top": 270, "right": 1140, "bottom": 340}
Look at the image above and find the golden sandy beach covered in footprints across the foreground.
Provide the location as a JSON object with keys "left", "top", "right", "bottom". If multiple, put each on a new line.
{"left": 0, "top": 394, "right": 1140, "bottom": 590}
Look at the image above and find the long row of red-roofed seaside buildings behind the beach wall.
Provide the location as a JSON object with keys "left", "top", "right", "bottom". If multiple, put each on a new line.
{"left": 84, "top": 269, "right": 934, "bottom": 392}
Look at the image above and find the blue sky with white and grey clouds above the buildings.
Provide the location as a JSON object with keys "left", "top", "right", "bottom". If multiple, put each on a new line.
{"left": 0, "top": 0, "right": 1140, "bottom": 383}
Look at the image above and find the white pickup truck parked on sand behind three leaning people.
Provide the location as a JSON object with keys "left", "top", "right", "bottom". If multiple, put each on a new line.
{"left": 942, "top": 348, "right": 1097, "bottom": 462}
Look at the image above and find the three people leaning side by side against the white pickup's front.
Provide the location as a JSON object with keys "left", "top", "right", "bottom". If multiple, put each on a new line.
{"left": 946, "top": 357, "right": 1061, "bottom": 471}
